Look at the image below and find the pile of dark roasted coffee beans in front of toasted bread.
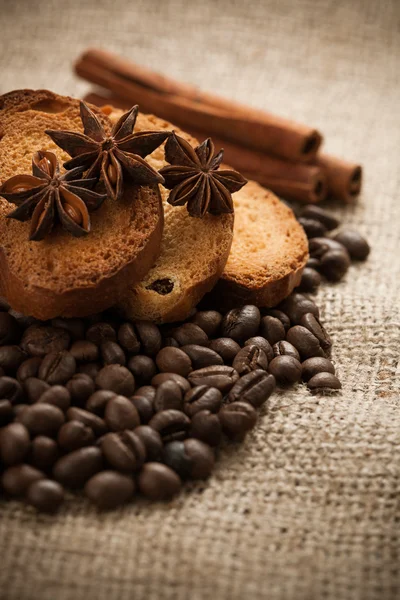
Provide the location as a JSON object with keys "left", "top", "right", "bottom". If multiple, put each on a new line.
{"left": 0, "top": 293, "right": 341, "bottom": 512}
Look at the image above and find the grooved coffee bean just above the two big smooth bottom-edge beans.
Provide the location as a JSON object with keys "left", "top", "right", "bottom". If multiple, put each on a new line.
{"left": 101, "top": 430, "right": 146, "bottom": 472}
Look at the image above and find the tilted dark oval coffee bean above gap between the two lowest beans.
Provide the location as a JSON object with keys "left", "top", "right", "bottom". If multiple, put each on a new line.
{"left": 53, "top": 446, "right": 103, "bottom": 488}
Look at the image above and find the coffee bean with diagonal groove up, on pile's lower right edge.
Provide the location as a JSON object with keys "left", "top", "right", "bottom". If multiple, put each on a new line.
{"left": 226, "top": 370, "right": 275, "bottom": 408}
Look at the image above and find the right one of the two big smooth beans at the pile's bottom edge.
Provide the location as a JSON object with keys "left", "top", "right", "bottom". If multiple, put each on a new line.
{"left": 138, "top": 462, "right": 182, "bottom": 500}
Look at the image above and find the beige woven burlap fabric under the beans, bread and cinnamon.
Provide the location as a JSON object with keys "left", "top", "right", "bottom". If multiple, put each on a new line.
{"left": 0, "top": 0, "right": 400, "bottom": 600}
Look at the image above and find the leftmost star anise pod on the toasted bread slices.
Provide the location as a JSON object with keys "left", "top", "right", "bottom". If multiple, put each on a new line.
{"left": 0, "top": 150, "right": 107, "bottom": 242}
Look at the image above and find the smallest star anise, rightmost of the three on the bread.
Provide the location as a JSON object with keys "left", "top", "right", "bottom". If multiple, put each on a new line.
{"left": 160, "top": 132, "right": 247, "bottom": 217}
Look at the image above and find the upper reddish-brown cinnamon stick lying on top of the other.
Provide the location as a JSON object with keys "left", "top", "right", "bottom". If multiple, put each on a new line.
{"left": 75, "top": 49, "right": 322, "bottom": 162}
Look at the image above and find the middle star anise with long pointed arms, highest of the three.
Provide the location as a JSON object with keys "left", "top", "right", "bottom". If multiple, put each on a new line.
{"left": 46, "top": 102, "right": 170, "bottom": 200}
